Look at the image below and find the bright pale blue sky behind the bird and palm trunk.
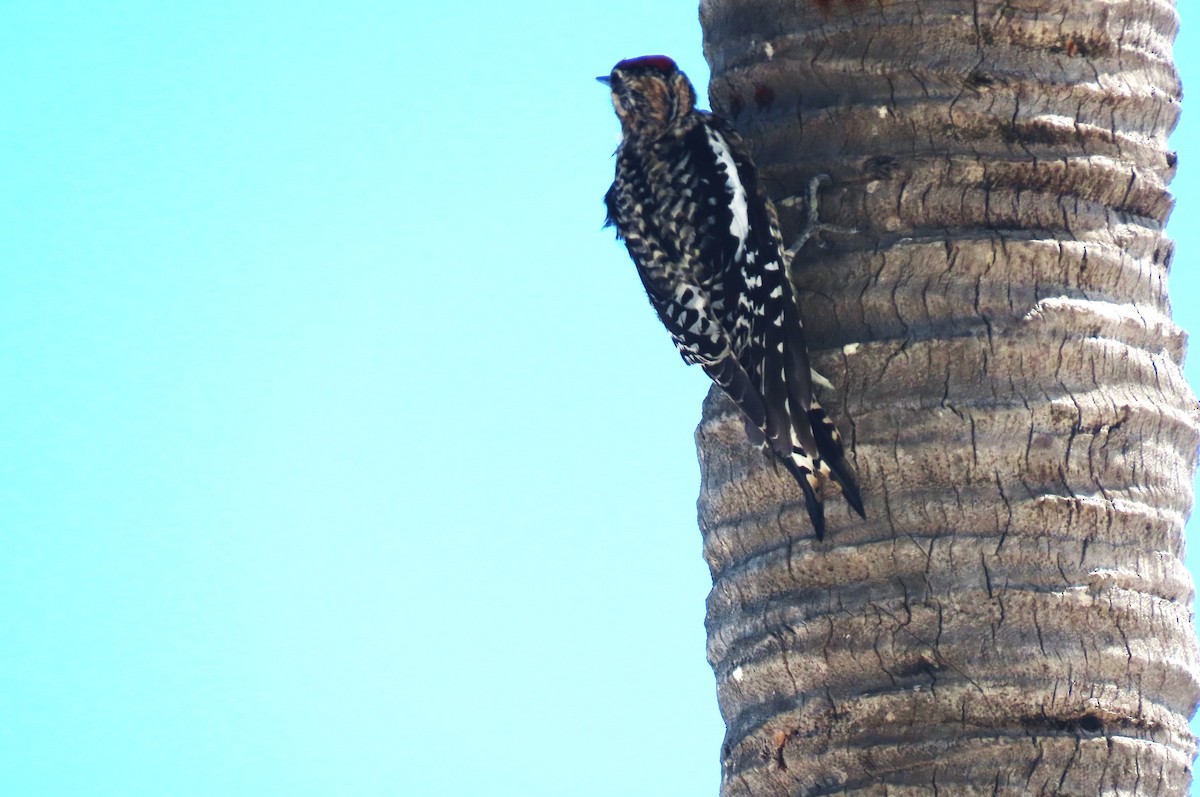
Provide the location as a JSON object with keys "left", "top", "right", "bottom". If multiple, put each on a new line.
{"left": 0, "top": 0, "right": 1200, "bottom": 797}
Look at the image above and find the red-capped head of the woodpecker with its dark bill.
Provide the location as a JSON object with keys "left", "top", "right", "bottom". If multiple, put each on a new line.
{"left": 596, "top": 55, "right": 696, "bottom": 137}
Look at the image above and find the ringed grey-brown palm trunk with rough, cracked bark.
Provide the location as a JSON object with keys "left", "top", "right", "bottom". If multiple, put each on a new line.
{"left": 697, "top": 0, "right": 1200, "bottom": 797}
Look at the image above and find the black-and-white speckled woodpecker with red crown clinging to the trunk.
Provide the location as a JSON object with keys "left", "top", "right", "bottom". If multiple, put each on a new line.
{"left": 596, "top": 55, "right": 865, "bottom": 539}
